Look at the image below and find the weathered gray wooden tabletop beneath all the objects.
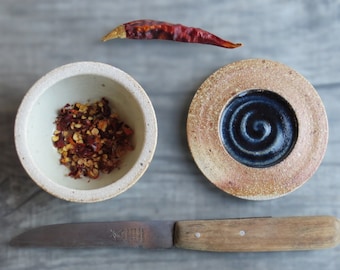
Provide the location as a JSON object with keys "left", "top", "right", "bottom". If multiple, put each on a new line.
{"left": 0, "top": 0, "right": 340, "bottom": 270}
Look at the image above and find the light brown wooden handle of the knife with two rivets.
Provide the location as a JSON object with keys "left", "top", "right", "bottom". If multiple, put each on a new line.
{"left": 174, "top": 216, "right": 340, "bottom": 252}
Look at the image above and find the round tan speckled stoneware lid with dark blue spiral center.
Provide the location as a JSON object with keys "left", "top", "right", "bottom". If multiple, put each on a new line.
{"left": 187, "top": 59, "right": 328, "bottom": 200}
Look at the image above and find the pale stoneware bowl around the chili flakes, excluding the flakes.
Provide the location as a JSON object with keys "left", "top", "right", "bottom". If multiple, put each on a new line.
{"left": 15, "top": 62, "right": 157, "bottom": 202}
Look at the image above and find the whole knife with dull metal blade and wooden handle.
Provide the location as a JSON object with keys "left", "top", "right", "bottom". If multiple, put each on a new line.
{"left": 10, "top": 216, "right": 340, "bottom": 252}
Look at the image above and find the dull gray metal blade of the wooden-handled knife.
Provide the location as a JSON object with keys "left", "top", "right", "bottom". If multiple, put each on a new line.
{"left": 10, "top": 221, "right": 175, "bottom": 249}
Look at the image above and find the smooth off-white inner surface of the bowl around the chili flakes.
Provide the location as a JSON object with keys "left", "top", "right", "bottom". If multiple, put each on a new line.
{"left": 22, "top": 71, "right": 145, "bottom": 190}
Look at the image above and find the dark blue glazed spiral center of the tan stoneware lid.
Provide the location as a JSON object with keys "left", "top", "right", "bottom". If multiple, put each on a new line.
{"left": 219, "top": 89, "right": 298, "bottom": 168}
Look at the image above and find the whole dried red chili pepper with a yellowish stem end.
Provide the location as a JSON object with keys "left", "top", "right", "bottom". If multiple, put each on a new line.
{"left": 102, "top": 20, "right": 242, "bottom": 49}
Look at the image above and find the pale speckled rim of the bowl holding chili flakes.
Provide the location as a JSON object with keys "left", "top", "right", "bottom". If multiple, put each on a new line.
{"left": 14, "top": 61, "right": 158, "bottom": 202}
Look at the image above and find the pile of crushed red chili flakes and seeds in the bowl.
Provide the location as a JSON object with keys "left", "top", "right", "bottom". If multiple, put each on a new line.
{"left": 52, "top": 98, "right": 134, "bottom": 179}
